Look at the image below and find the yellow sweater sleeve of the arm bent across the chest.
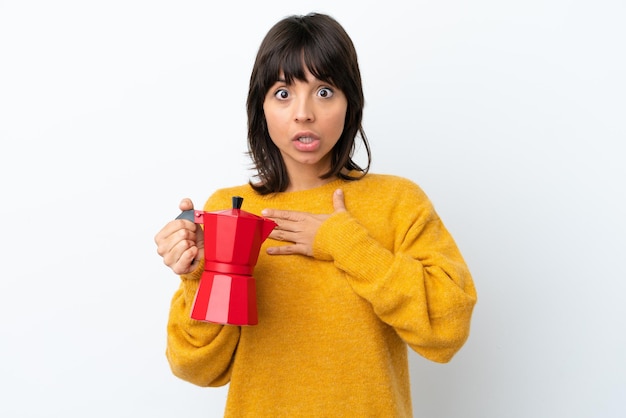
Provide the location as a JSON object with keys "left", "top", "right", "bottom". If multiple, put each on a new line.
{"left": 313, "top": 183, "right": 476, "bottom": 363}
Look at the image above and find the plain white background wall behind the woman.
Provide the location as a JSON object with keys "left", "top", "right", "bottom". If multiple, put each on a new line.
{"left": 0, "top": 0, "right": 626, "bottom": 418}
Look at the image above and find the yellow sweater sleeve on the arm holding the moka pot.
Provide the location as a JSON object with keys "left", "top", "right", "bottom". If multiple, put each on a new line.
{"left": 166, "top": 263, "right": 240, "bottom": 386}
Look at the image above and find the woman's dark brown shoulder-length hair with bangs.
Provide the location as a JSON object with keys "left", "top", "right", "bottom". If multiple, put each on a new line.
{"left": 247, "top": 13, "right": 371, "bottom": 194}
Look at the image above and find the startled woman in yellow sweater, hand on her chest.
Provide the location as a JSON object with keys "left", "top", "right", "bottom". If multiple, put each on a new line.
{"left": 155, "top": 14, "right": 476, "bottom": 417}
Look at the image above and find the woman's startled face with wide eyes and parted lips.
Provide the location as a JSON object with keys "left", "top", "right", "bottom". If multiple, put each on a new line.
{"left": 263, "top": 68, "right": 348, "bottom": 177}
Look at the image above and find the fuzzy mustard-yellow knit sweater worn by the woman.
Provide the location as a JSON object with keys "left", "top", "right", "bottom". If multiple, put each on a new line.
{"left": 166, "top": 174, "right": 476, "bottom": 418}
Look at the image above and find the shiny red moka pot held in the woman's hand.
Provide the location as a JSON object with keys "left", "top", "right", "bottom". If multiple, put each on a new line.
{"left": 179, "top": 196, "right": 276, "bottom": 325}
